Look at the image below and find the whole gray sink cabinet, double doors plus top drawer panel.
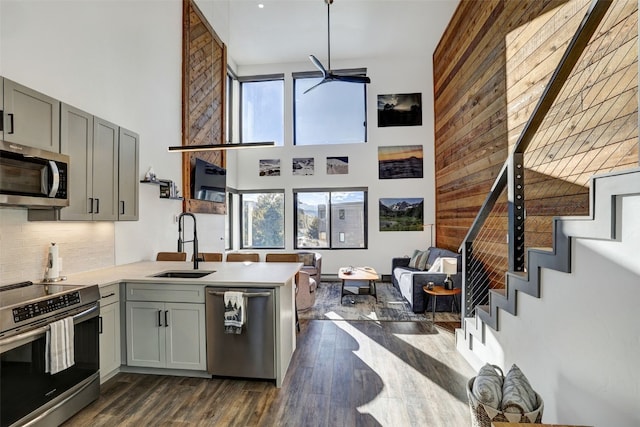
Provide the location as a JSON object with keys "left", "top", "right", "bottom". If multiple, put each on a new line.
{"left": 126, "top": 283, "right": 207, "bottom": 371}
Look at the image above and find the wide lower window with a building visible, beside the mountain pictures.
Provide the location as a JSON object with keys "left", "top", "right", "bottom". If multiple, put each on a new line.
{"left": 294, "top": 189, "right": 367, "bottom": 249}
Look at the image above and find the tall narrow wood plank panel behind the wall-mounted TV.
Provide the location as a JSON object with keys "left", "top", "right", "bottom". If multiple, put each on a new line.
{"left": 182, "top": 0, "right": 227, "bottom": 214}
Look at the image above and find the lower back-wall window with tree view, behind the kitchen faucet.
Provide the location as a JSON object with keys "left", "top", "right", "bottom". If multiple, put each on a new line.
{"left": 240, "top": 190, "right": 284, "bottom": 249}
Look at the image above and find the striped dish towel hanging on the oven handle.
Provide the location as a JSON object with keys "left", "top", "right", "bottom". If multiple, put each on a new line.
{"left": 44, "top": 317, "right": 75, "bottom": 375}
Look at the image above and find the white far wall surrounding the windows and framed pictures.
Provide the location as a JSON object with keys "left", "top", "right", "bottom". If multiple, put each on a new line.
{"left": 235, "top": 54, "right": 435, "bottom": 274}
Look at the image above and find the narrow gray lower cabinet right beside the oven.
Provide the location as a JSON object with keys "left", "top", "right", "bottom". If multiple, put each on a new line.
{"left": 100, "top": 284, "right": 120, "bottom": 383}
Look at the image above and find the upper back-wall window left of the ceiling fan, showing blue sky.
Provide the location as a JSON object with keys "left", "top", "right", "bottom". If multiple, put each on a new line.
{"left": 238, "top": 74, "right": 284, "bottom": 145}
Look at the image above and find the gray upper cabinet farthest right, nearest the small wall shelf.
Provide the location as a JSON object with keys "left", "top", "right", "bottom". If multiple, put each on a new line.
{"left": 118, "top": 128, "right": 140, "bottom": 221}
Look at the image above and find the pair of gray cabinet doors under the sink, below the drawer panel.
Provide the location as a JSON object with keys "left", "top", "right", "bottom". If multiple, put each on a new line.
{"left": 126, "top": 301, "right": 207, "bottom": 371}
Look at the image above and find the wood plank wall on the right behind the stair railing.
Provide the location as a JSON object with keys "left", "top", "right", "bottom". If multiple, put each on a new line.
{"left": 433, "top": 0, "right": 638, "bottom": 284}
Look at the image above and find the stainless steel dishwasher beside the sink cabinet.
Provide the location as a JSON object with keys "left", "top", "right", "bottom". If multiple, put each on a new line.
{"left": 205, "top": 287, "right": 276, "bottom": 379}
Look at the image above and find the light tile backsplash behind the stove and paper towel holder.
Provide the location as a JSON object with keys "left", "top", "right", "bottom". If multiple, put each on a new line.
{"left": 0, "top": 208, "right": 115, "bottom": 285}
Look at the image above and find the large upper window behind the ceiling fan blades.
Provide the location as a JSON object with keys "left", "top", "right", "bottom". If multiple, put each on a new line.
{"left": 293, "top": 70, "right": 367, "bottom": 145}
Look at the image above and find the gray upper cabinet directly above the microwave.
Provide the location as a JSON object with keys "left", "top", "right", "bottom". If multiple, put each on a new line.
{"left": 2, "top": 78, "right": 60, "bottom": 153}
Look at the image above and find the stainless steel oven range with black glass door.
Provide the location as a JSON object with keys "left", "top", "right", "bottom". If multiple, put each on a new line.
{"left": 0, "top": 282, "right": 100, "bottom": 426}
